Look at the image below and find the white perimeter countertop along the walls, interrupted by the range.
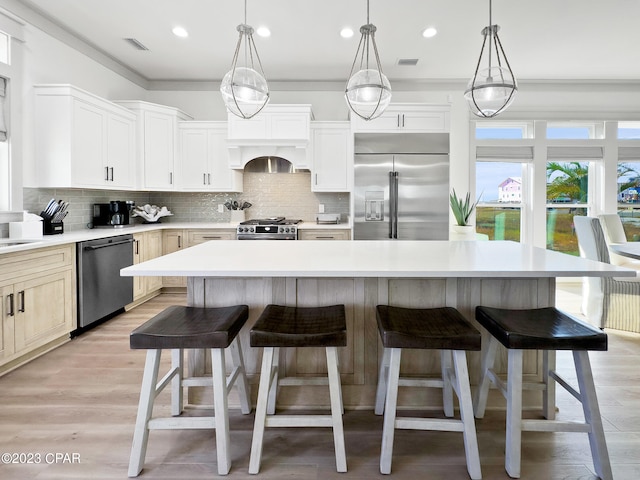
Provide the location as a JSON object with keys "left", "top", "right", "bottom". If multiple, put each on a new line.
{"left": 0, "top": 222, "right": 351, "bottom": 255}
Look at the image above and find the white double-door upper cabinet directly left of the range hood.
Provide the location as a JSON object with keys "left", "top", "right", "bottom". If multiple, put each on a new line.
{"left": 178, "top": 122, "right": 243, "bottom": 192}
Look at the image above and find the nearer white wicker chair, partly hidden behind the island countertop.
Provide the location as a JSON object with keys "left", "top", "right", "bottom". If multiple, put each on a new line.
{"left": 573, "top": 216, "right": 640, "bottom": 332}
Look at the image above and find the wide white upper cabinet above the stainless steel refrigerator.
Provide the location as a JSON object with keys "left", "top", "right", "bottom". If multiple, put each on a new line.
{"left": 351, "top": 103, "right": 451, "bottom": 132}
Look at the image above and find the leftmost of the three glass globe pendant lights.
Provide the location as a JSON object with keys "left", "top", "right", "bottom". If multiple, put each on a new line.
{"left": 220, "top": 0, "right": 269, "bottom": 119}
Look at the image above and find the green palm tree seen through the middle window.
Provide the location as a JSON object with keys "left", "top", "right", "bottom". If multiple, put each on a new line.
{"left": 547, "top": 162, "right": 589, "bottom": 203}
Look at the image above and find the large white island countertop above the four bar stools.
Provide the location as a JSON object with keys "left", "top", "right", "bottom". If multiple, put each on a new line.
{"left": 121, "top": 240, "right": 635, "bottom": 278}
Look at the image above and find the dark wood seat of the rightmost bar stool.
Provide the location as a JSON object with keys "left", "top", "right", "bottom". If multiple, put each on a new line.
{"left": 476, "top": 307, "right": 607, "bottom": 350}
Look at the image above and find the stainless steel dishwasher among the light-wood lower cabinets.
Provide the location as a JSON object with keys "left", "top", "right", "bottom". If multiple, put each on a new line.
{"left": 72, "top": 235, "right": 133, "bottom": 335}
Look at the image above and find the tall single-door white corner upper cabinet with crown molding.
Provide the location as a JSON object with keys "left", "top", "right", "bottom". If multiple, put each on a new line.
{"left": 115, "top": 101, "right": 192, "bottom": 191}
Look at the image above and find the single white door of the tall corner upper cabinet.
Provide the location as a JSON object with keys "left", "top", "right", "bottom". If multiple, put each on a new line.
{"left": 144, "top": 112, "right": 175, "bottom": 190}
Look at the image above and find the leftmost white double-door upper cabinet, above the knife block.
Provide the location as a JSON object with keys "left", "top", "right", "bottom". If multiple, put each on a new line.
{"left": 34, "top": 85, "right": 136, "bottom": 189}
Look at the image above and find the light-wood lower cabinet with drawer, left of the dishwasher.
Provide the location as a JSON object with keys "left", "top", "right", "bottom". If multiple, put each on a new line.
{"left": 0, "top": 244, "right": 77, "bottom": 373}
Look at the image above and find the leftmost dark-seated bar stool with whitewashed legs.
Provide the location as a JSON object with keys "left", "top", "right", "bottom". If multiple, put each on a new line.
{"left": 129, "top": 305, "right": 251, "bottom": 477}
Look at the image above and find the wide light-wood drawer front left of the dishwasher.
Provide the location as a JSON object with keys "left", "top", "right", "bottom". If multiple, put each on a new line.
{"left": 0, "top": 243, "right": 76, "bottom": 283}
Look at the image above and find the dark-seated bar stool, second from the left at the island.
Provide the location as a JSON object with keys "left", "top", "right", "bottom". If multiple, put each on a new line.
{"left": 249, "top": 305, "right": 347, "bottom": 474}
